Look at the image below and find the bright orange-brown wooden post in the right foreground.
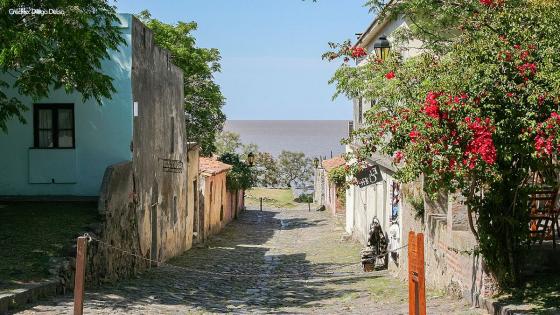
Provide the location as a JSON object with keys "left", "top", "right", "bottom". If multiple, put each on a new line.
{"left": 408, "top": 231, "right": 426, "bottom": 315}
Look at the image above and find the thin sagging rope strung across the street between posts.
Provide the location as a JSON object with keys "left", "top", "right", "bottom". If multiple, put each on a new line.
{"left": 83, "top": 233, "right": 408, "bottom": 278}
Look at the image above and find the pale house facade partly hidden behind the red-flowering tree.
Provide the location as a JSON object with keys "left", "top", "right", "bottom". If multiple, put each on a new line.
{"left": 346, "top": 10, "right": 494, "bottom": 305}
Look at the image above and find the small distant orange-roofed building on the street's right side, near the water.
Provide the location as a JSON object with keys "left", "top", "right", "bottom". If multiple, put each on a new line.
{"left": 313, "top": 156, "right": 346, "bottom": 215}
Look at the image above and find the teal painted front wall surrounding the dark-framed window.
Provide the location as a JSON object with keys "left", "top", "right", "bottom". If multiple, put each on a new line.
{"left": 0, "top": 14, "right": 133, "bottom": 196}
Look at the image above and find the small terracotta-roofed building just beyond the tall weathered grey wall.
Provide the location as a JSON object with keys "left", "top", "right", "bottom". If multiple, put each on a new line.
{"left": 195, "top": 157, "right": 245, "bottom": 243}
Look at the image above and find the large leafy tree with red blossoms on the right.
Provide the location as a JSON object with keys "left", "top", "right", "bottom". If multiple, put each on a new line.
{"left": 325, "top": 0, "right": 560, "bottom": 284}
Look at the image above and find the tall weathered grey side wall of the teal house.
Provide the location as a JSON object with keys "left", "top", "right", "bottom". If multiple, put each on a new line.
{"left": 132, "top": 18, "right": 188, "bottom": 260}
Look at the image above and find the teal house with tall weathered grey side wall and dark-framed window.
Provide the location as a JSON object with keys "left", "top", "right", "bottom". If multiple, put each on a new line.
{"left": 0, "top": 14, "right": 198, "bottom": 281}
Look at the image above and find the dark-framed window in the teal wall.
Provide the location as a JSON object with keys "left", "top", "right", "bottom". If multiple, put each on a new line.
{"left": 33, "top": 104, "right": 75, "bottom": 148}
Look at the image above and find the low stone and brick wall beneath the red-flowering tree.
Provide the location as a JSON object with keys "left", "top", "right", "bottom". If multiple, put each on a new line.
{"left": 391, "top": 182, "right": 495, "bottom": 305}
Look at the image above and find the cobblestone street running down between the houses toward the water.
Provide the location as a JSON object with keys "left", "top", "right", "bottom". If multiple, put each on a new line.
{"left": 15, "top": 210, "right": 480, "bottom": 314}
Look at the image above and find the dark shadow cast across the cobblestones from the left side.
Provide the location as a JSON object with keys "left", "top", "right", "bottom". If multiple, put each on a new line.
{"left": 57, "top": 210, "right": 375, "bottom": 313}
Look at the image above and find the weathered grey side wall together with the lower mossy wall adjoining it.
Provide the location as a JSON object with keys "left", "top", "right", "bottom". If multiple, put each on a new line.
{"left": 74, "top": 17, "right": 190, "bottom": 283}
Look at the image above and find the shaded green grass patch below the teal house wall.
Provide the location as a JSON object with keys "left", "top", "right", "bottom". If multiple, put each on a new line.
{"left": 0, "top": 202, "right": 98, "bottom": 290}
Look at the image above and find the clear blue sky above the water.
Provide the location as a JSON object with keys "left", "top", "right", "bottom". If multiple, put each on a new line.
{"left": 115, "top": 0, "right": 374, "bottom": 120}
